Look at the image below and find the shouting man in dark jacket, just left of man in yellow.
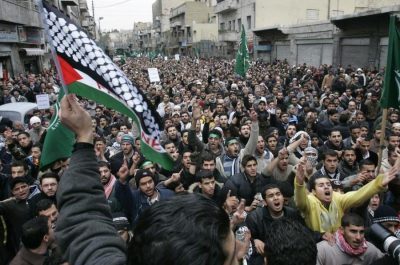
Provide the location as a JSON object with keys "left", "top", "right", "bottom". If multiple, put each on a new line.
{"left": 246, "top": 184, "right": 304, "bottom": 265}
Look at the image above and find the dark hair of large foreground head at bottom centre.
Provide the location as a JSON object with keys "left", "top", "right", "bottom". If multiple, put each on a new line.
{"left": 127, "top": 194, "right": 231, "bottom": 265}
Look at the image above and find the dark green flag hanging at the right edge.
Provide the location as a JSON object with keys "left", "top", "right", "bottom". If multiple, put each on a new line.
{"left": 381, "top": 16, "right": 400, "bottom": 109}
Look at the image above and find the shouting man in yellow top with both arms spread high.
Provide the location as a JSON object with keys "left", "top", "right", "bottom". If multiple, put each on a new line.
{"left": 294, "top": 157, "right": 399, "bottom": 233}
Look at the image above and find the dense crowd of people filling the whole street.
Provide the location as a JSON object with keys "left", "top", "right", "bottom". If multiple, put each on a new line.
{"left": 0, "top": 57, "right": 400, "bottom": 265}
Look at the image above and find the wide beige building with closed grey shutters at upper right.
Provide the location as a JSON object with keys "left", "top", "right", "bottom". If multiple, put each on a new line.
{"left": 254, "top": 0, "right": 399, "bottom": 67}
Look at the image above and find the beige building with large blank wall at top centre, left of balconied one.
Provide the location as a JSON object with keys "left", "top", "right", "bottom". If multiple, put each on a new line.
{"left": 167, "top": 2, "right": 218, "bottom": 55}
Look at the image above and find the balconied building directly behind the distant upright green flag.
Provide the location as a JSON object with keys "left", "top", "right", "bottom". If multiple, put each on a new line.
{"left": 214, "top": 0, "right": 255, "bottom": 58}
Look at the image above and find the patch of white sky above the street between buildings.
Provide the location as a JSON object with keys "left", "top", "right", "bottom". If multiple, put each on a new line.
{"left": 91, "top": 0, "right": 154, "bottom": 31}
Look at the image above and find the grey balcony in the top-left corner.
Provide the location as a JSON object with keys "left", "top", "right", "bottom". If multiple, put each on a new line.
{"left": 0, "top": 0, "right": 41, "bottom": 28}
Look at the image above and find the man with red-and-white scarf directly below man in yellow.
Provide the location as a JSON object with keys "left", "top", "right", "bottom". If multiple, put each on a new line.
{"left": 317, "top": 213, "right": 384, "bottom": 265}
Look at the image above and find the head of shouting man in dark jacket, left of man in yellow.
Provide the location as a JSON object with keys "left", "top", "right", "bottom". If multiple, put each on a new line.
{"left": 261, "top": 184, "right": 284, "bottom": 217}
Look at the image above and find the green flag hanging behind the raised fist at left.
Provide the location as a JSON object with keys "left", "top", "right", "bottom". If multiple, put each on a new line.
{"left": 40, "top": 89, "right": 75, "bottom": 171}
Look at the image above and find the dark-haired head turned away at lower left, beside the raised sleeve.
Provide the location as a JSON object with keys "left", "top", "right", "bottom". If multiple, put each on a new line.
{"left": 21, "top": 216, "right": 54, "bottom": 250}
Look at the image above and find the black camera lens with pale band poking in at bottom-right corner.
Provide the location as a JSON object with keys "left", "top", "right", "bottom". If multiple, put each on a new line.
{"left": 370, "top": 224, "right": 400, "bottom": 264}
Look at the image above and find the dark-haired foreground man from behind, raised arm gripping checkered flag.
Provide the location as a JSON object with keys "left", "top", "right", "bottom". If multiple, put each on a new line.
{"left": 57, "top": 94, "right": 252, "bottom": 265}
